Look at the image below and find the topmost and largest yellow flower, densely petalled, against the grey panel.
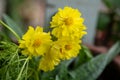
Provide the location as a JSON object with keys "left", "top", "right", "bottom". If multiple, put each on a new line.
{"left": 50, "top": 7, "right": 86, "bottom": 38}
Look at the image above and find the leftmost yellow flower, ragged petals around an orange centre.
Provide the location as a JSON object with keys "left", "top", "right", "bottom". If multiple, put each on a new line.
{"left": 19, "top": 26, "right": 52, "bottom": 56}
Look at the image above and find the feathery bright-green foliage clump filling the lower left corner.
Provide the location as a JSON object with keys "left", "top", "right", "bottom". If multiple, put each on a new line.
{"left": 0, "top": 41, "right": 31, "bottom": 80}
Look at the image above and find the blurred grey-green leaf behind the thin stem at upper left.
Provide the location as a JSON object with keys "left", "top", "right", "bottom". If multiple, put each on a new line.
{"left": 3, "top": 15, "right": 23, "bottom": 37}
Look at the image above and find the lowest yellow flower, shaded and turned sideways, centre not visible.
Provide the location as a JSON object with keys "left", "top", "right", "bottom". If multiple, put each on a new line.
{"left": 39, "top": 47, "right": 60, "bottom": 72}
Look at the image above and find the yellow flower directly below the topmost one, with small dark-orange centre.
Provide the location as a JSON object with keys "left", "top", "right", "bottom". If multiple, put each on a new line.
{"left": 53, "top": 38, "right": 81, "bottom": 60}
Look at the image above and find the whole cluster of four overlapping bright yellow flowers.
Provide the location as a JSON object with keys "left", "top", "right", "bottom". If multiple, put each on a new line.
{"left": 19, "top": 7, "right": 86, "bottom": 71}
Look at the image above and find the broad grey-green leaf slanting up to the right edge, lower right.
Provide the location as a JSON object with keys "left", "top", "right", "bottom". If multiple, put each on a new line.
{"left": 69, "top": 42, "right": 120, "bottom": 80}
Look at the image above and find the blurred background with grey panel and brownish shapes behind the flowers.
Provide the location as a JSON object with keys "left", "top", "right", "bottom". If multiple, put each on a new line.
{"left": 0, "top": 0, "right": 120, "bottom": 80}
